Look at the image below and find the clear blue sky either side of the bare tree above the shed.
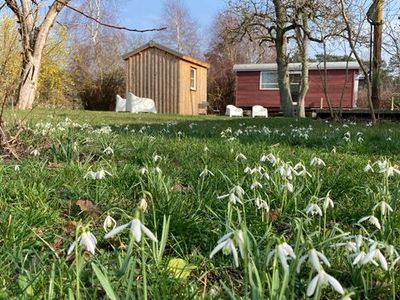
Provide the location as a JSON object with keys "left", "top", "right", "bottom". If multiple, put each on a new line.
{"left": 120, "top": 0, "right": 226, "bottom": 32}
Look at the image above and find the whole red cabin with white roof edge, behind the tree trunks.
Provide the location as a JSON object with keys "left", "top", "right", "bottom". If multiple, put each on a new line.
{"left": 233, "top": 62, "right": 360, "bottom": 108}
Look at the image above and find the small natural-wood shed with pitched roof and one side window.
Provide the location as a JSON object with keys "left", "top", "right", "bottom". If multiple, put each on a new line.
{"left": 123, "top": 41, "right": 210, "bottom": 115}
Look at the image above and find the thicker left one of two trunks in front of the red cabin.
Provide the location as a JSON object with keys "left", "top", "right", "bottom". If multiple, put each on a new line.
{"left": 274, "top": 0, "right": 293, "bottom": 117}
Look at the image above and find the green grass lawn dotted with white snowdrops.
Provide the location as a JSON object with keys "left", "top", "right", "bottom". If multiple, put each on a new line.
{"left": 0, "top": 110, "right": 400, "bottom": 299}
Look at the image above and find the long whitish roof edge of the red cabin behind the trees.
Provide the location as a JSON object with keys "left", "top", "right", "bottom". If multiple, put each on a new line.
{"left": 233, "top": 61, "right": 360, "bottom": 72}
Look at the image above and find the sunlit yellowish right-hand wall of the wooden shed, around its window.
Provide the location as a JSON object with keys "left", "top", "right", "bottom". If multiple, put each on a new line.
{"left": 179, "top": 60, "right": 207, "bottom": 115}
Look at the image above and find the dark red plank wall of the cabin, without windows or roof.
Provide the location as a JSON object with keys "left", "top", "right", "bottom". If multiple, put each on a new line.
{"left": 235, "top": 70, "right": 357, "bottom": 108}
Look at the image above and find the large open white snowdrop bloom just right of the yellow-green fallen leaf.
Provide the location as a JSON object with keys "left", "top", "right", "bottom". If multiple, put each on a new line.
{"left": 210, "top": 230, "right": 244, "bottom": 267}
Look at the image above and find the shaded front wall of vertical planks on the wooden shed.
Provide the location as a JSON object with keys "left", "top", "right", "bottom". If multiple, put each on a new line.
{"left": 126, "top": 48, "right": 180, "bottom": 113}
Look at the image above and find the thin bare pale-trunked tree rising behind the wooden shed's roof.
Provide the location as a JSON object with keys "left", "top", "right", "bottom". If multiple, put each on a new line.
{"left": 155, "top": 0, "right": 201, "bottom": 57}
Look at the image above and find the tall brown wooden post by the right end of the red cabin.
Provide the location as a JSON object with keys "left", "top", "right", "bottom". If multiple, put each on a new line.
{"left": 371, "top": 0, "right": 385, "bottom": 110}
